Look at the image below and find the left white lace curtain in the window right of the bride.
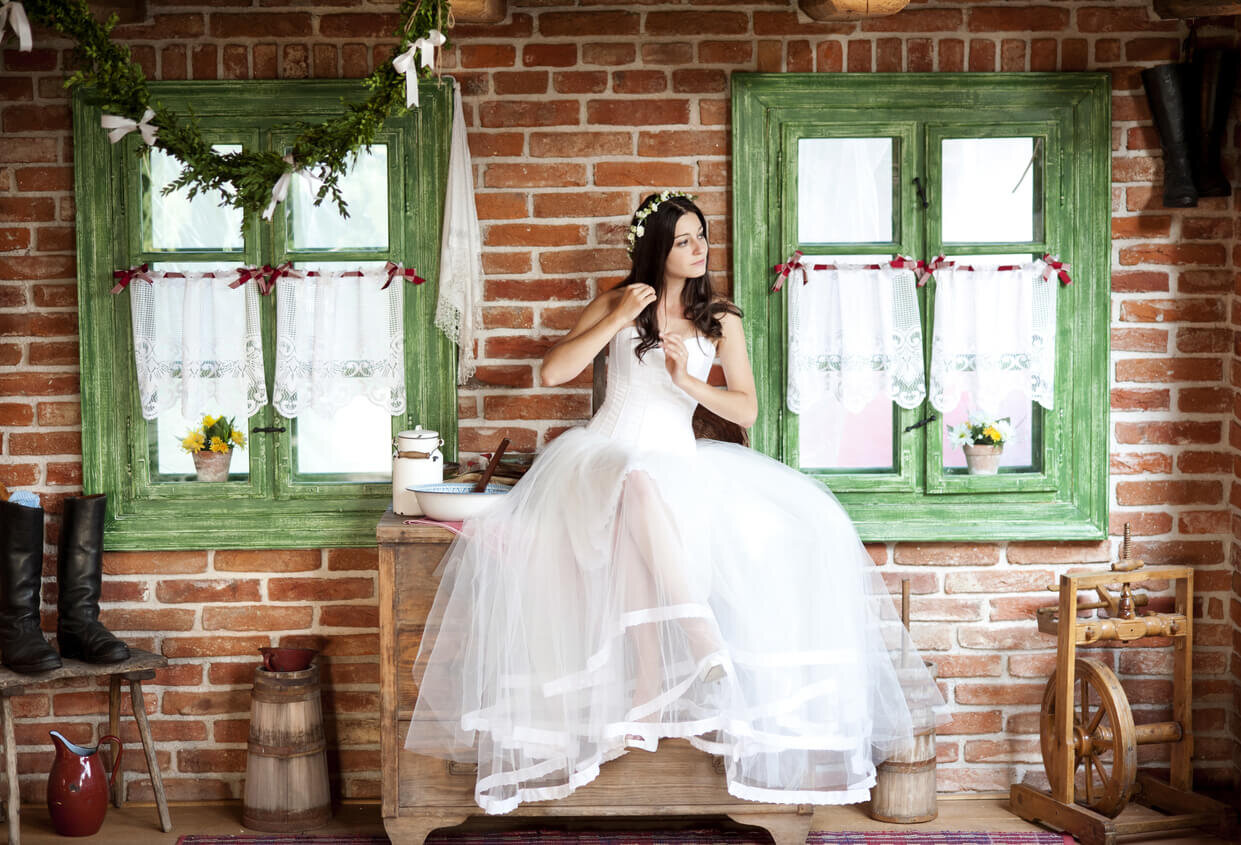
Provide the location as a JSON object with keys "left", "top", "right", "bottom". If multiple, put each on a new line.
{"left": 788, "top": 264, "right": 926, "bottom": 413}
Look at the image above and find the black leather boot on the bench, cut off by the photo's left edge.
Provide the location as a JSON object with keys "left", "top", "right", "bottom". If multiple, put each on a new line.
{"left": 0, "top": 501, "right": 61, "bottom": 675}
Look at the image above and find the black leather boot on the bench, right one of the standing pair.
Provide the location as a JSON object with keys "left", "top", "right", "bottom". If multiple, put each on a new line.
{"left": 56, "top": 494, "right": 129, "bottom": 663}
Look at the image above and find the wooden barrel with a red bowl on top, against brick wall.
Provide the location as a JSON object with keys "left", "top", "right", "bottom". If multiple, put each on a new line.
{"left": 242, "top": 665, "right": 331, "bottom": 833}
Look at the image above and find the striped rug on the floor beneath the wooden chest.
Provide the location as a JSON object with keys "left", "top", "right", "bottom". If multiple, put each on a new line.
{"left": 177, "top": 830, "right": 1075, "bottom": 845}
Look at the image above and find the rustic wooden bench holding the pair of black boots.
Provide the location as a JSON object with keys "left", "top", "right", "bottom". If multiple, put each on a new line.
{"left": 0, "top": 649, "right": 172, "bottom": 845}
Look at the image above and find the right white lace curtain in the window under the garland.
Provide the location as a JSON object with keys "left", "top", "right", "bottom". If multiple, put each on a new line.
{"left": 273, "top": 269, "right": 405, "bottom": 418}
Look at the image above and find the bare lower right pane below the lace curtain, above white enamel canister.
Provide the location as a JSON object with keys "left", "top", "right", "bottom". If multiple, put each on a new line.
{"left": 293, "top": 396, "right": 392, "bottom": 481}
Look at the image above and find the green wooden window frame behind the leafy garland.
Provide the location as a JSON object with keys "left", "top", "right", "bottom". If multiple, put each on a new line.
{"left": 73, "top": 79, "right": 457, "bottom": 551}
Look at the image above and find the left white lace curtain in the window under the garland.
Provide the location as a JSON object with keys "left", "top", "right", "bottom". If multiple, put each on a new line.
{"left": 129, "top": 272, "right": 267, "bottom": 419}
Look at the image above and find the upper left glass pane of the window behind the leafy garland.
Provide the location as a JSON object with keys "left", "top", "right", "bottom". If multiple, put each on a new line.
{"left": 143, "top": 144, "right": 242, "bottom": 251}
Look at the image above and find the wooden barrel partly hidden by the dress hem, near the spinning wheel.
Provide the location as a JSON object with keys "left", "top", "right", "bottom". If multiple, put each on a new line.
{"left": 870, "top": 663, "right": 939, "bottom": 824}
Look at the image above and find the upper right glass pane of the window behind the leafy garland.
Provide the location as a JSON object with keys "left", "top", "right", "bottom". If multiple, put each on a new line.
{"left": 288, "top": 144, "right": 388, "bottom": 249}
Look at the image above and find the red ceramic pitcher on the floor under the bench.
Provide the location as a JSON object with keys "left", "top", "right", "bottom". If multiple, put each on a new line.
{"left": 47, "top": 731, "right": 123, "bottom": 836}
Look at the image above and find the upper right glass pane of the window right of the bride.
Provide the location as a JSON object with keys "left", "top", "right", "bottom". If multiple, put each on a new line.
{"left": 942, "top": 138, "right": 1042, "bottom": 243}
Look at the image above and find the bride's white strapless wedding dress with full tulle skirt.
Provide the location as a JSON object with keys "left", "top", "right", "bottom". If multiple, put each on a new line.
{"left": 406, "top": 326, "right": 943, "bottom": 813}
